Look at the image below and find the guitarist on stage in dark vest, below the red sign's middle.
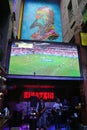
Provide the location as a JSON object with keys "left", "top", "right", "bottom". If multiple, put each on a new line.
{"left": 37, "top": 97, "right": 46, "bottom": 130}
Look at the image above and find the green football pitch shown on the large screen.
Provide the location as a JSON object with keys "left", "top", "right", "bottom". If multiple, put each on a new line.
{"left": 9, "top": 54, "right": 80, "bottom": 77}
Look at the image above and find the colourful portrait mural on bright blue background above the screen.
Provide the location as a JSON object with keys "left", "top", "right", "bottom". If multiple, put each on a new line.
{"left": 20, "top": 0, "right": 62, "bottom": 42}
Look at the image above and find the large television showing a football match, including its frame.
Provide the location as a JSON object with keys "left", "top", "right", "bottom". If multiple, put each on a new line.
{"left": 7, "top": 40, "right": 82, "bottom": 80}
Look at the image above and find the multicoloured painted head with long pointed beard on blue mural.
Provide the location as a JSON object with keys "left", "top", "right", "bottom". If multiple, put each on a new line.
{"left": 30, "top": 7, "right": 59, "bottom": 40}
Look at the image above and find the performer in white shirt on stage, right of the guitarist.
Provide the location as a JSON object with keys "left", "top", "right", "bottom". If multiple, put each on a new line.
{"left": 52, "top": 98, "right": 62, "bottom": 130}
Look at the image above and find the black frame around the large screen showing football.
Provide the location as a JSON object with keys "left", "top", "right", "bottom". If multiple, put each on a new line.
{"left": 6, "top": 39, "right": 83, "bottom": 80}
